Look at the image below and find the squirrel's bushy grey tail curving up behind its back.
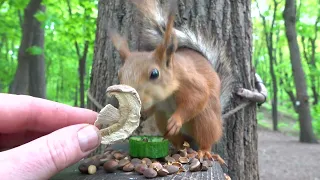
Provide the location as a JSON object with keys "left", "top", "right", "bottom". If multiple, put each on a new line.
{"left": 131, "top": 0, "right": 234, "bottom": 112}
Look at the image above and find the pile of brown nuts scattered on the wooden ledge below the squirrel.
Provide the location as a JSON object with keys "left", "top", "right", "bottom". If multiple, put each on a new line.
{"left": 78, "top": 143, "right": 220, "bottom": 178}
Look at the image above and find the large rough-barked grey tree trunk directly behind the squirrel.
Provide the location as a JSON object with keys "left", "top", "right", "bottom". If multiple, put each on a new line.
{"left": 88, "top": 0, "right": 259, "bottom": 180}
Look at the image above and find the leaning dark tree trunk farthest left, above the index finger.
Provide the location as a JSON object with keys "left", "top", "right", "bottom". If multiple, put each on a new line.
{"left": 9, "top": 0, "right": 41, "bottom": 94}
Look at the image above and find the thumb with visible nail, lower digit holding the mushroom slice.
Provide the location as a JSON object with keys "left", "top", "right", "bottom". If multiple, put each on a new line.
{"left": 0, "top": 124, "right": 101, "bottom": 180}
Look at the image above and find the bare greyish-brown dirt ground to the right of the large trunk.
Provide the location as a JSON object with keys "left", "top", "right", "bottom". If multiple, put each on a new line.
{"left": 258, "top": 107, "right": 320, "bottom": 180}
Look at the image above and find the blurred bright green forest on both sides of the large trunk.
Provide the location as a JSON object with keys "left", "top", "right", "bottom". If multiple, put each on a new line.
{"left": 0, "top": 0, "right": 320, "bottom": 138}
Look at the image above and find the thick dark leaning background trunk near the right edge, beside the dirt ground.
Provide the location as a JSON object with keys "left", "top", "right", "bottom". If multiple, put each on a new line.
{"left": 283, "top": 0, "right": 317, "bottom": 143}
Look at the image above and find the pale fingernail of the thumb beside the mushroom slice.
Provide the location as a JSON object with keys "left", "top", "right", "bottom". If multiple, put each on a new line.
{"left": 78, "top": 125, "right": 100, "bottom": 152}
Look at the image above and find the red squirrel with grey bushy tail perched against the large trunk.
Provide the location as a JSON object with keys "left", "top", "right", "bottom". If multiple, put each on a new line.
{"left": 110, "top": 0, "right": 232, "bottom": 163}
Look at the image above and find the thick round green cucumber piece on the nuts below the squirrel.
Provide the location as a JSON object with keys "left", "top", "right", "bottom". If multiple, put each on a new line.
{"left": 129, "top": 136, "right": 169, "bottom": 159}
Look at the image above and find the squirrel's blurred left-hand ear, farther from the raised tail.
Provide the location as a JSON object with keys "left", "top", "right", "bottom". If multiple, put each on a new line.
{"left": 108, "top": 28, "right": 130, "bottom": 62}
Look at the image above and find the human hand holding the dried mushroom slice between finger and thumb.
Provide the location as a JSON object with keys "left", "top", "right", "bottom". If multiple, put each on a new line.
{"left": 0, "top": 93, "right": 101, "bottom": 180}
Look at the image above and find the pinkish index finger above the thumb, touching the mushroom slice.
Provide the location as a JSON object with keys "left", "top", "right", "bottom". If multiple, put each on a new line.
{"left": 0, "top": 93, "right": 98, "bottom": 133}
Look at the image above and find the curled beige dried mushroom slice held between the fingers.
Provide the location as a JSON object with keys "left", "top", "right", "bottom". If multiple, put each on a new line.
{"left": 94, "top": 85, "right": 141, "bottom": 144}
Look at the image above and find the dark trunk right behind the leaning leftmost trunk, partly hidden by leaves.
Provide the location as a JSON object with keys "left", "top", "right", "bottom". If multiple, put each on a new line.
{"left": 28, "top": 6, "right": 46, "bottom": 99}
